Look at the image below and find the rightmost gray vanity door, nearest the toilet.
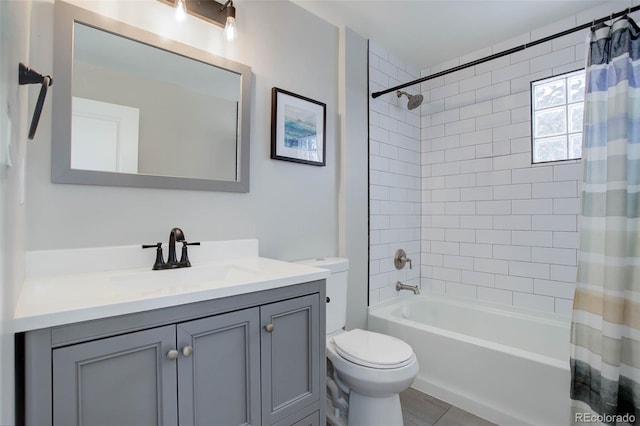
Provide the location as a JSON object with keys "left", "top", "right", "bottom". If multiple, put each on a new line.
{"left": 260, "top": 294, "right": 324, "bottom": 425}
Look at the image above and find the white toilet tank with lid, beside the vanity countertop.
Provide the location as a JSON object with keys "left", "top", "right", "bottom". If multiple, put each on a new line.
{"left": 296, "top": 257, "right": 349, "bottom": 334}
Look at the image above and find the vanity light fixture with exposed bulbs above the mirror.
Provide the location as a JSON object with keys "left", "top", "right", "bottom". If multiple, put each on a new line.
{"left": 159, "top": 0, "right": 238, "bottom": 41}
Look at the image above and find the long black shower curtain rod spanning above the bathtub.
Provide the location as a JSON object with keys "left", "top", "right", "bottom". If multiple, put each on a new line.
{"left": 371, "top": 6, "right": 640, "bottom": 99}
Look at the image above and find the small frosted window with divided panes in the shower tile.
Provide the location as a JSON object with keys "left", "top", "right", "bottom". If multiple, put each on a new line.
{"left": 531, "top": 70, "right": 585, "bottom": 163}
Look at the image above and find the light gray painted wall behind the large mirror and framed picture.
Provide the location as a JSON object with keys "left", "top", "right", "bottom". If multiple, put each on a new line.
{"left": 27, "top": 0, "right": 339, "bottom": 261}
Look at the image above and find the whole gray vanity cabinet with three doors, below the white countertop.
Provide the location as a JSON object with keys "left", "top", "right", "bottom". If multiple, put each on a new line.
{"left": 23, "top": 281, "right": 325, "bottom": 426}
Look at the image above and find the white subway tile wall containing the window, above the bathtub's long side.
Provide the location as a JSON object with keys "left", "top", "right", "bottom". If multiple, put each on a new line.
{"left": 420, "top": 17, "right": 585, "bottom": 315}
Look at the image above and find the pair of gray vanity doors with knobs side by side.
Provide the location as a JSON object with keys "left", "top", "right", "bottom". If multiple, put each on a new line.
{"left": 53, "top": 308, "right": 260, "bottom": 426}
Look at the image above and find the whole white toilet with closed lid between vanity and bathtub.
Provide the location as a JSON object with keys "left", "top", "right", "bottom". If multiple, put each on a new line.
{"left": 300, "top": 257, "right": 418, "bottom": 426}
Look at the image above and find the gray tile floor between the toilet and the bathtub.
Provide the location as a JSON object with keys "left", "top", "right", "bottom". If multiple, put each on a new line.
{"left": 400, "top": 388, "right": 494, "bottom": 426}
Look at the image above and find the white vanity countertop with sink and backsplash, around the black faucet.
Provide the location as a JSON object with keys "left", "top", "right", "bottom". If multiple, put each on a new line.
{"left": 14, "top": 240, "right": 329, "bottom": 332}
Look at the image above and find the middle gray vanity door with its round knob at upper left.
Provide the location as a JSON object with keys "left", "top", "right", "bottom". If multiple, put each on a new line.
{"left": 177, "top": 308, "right": 261, "bottom": 426}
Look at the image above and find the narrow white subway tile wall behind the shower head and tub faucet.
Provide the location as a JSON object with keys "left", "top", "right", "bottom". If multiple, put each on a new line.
{"left": 369, "top": 42, "right": 422, "bottom": 305}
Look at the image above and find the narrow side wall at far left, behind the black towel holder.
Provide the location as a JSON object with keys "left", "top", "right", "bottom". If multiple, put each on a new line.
{"left": 0, "top": 1, "right": 30, "bottom": 425}
